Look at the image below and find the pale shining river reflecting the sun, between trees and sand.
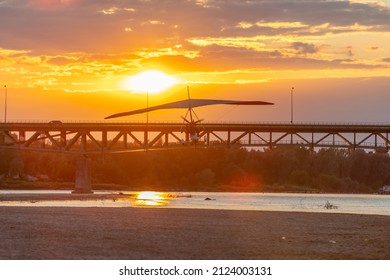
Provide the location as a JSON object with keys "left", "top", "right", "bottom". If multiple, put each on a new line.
{"left": 0, "top": 190, "right": 390, "bottom": 216}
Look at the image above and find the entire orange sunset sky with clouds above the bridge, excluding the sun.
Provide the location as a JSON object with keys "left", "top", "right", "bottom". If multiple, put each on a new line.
{"left": 0, "top": 0, "right": 390, "bottom": 122}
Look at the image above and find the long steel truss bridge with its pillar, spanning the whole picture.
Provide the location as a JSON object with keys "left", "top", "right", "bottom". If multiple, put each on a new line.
{"left": 0, "top": 121, "right": 390, "bottom": 192}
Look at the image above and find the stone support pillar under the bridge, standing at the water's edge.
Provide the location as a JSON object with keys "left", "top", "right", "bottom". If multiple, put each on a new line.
{"left": 72, "top": 155, "right": 93, "bottom": 194}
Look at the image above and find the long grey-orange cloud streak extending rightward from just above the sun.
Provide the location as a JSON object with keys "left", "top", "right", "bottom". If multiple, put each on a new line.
{"left": 140, "top": 44, "right": 383, "bottom": 73}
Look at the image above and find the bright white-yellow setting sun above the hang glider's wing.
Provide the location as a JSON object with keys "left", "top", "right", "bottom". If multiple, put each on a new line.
{"left": 123, "top": 70, "right": 177, "bottom": 94}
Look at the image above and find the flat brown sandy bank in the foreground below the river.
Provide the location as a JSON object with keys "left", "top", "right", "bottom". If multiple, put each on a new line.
{"left": 0, "top": 206, "right": 390, "bottom": 260}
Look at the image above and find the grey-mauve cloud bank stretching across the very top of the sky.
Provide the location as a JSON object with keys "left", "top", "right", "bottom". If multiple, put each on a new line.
{"left": 0, "top": 0, "right": 390, "bottom": 53}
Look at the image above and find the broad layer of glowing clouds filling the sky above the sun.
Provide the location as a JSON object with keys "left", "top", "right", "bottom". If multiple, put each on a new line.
{"left": 0, "top": 0, "right": 390, "bottom": 91}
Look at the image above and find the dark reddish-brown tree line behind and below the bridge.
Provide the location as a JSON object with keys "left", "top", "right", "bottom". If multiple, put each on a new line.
{"left": 0, "top": 147, "right": 390, "bottom": 193}
